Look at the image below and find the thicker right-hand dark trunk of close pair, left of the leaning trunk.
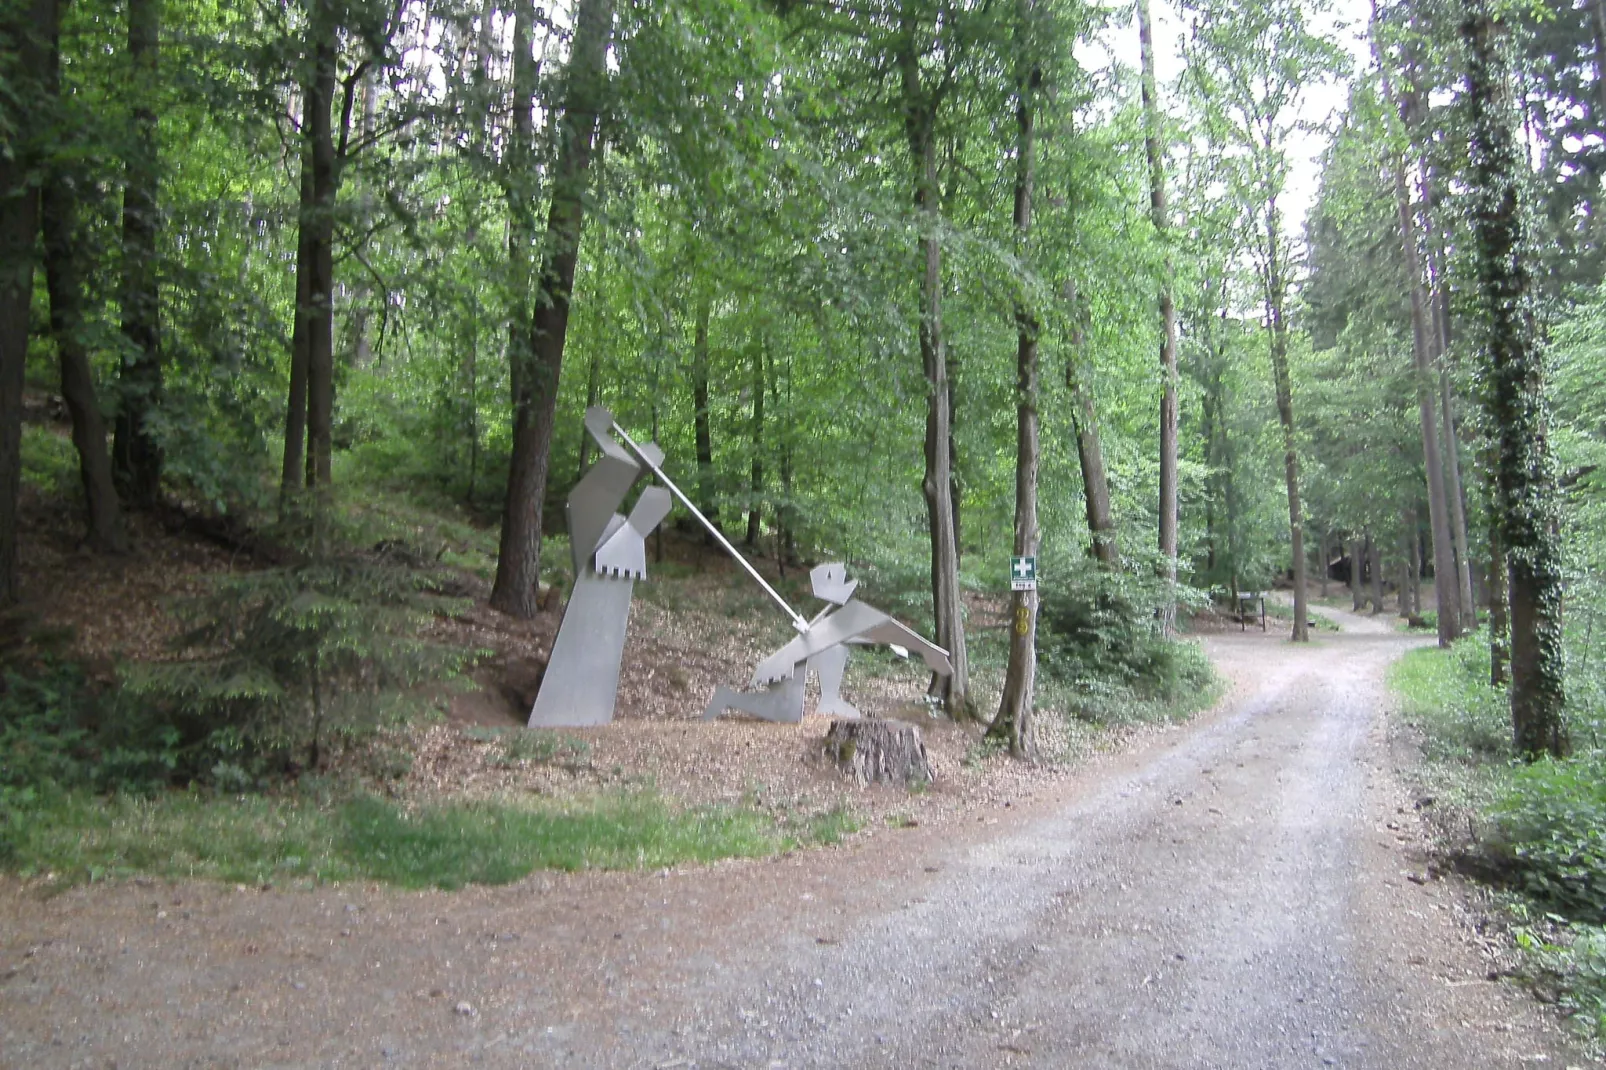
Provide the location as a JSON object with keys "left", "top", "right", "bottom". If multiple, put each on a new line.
{"left": 304, "top": 12, "right": 339, "bottom": 487}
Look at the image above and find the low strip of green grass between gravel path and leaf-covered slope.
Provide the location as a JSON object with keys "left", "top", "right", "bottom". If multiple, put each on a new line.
{"left": 0, "top": 792, "right": 858, "bottom": 888}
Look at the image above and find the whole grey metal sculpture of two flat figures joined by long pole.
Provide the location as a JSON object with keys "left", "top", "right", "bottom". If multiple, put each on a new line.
{"left": 530, "top": 408, "right": 952, "bottom": 728}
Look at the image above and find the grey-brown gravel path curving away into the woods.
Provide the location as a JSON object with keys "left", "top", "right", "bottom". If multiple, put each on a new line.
{"left": 0, "top": 609, "right": 1582, "bottom": 1070}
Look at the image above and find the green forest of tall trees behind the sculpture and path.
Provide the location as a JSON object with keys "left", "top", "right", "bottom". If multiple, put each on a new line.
{"left": 0, "top": 0, "right": 1606, "bottom": 957}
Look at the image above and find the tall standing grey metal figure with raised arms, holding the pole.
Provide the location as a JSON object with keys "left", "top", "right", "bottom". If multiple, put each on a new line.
{"left": 530, "top": 408, "right": 675, "bottom": 728}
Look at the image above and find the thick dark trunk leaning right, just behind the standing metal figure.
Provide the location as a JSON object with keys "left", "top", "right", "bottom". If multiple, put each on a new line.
{"left": 490, "top": 0, "right": 613, "bottom": 617}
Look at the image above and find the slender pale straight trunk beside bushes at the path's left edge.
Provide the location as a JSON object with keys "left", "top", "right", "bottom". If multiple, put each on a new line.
{"left": 1137, "top": 0, "right": 1182, "bottom": 631}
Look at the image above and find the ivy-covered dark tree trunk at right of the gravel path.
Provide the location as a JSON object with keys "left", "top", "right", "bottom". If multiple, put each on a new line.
{"left": 1461, "top": 0, "right": 1569, "bottom": 758}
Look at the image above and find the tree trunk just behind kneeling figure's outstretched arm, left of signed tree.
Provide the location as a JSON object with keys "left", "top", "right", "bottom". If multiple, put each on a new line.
{"left": 898, "top": 22, "right": 973, "bottom": 718}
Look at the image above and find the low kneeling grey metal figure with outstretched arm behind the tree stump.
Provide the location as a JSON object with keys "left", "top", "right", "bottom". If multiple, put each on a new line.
{"left": 703, "top": 562, "right": 954, "bottom": 723}
